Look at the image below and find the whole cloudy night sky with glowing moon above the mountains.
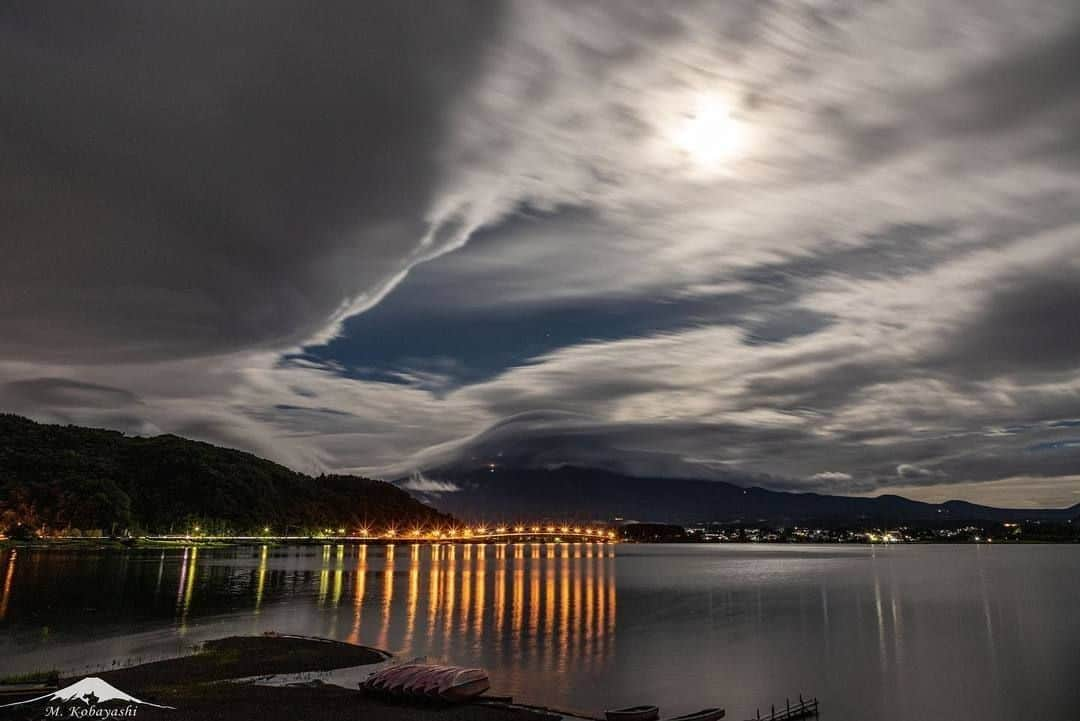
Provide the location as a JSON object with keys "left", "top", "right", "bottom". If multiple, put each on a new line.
{"left": 0, "top": 0, "right": 1080, "bottom": 506}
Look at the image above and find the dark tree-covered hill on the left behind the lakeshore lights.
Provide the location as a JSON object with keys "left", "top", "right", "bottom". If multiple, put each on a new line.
{"left": 0, "top": 414, "right": 448, "bottom": 534}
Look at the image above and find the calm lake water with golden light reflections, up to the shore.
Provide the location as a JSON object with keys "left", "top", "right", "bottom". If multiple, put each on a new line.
{"left": 0, "top": 544, "right": 1080, "bottom": 721}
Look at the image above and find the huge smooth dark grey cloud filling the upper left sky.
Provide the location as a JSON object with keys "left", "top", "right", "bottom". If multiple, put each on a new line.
{"left": 0, "top": 1, "right": 497, "bottom": 362}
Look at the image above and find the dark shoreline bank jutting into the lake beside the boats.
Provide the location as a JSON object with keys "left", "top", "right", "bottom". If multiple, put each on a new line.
{"left": 0, "top": 636, "right": 559, "bottom": 721}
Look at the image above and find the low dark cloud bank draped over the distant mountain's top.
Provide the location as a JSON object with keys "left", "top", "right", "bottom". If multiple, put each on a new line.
{"left": 418, "top": 410, "right": 1080, "bottom": 493}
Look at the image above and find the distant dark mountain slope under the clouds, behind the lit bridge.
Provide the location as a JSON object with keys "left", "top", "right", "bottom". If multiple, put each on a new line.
{"left": 412, "top": 465, "right": 1080, "bottom": 523}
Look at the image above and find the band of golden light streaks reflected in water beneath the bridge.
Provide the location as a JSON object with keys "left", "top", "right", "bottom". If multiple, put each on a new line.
{"left": 198, "top": 543, "right": 616, "bottom": 672}
